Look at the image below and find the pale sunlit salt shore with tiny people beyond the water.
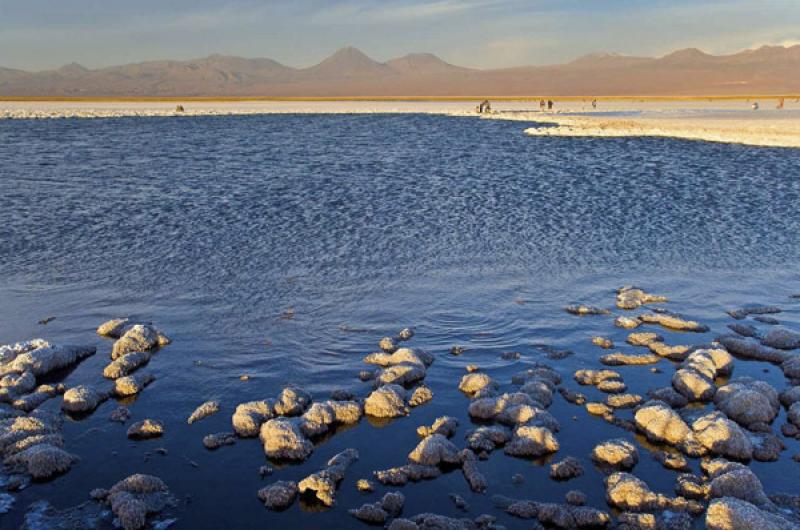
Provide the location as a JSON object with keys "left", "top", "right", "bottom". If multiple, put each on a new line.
{"left": 0, "top": 96, "right": 800, "bottom": 148}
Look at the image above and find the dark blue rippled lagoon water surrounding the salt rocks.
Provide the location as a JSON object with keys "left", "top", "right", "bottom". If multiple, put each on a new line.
{"left": 0, "top": 116, "right": 800, "bottom": 528}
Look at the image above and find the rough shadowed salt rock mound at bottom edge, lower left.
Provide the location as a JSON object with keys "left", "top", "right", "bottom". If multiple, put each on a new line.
{"left": 106, "top": 474, "right": 175, "bottom": 530}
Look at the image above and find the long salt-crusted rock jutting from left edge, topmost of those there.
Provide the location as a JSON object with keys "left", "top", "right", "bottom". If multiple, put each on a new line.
{"left": 0, "top": 339, "right": 97, "bottom": 377}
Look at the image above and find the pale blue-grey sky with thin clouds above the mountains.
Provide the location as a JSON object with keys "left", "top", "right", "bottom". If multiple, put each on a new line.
{"left": 0, "top": 0, "right": 800, "bottom": 70}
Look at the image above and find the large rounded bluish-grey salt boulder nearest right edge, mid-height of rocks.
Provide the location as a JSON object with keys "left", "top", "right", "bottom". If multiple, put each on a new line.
{"left": 714, "top": 377, "right": 780, "bottom": 427}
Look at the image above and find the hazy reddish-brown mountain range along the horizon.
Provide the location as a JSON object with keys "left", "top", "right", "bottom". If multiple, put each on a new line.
{"left": 0, "top": 45, "right": 800, "bottom": 97}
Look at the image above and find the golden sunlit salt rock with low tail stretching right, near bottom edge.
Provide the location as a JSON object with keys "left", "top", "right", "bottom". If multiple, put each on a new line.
{"left": 606, "top": 473, "right": 703, "bottom": 513}
